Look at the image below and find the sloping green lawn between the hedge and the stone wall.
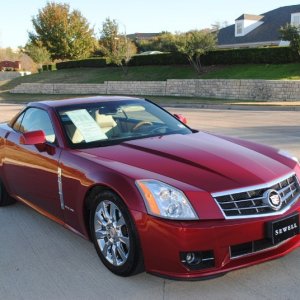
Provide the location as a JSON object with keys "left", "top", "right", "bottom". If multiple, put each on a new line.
{"left": 0, "top": 63, "right": 300, "bottom": 92}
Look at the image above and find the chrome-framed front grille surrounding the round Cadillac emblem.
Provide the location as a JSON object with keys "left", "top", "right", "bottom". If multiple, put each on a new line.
{"left": 213, "top": 174, "right": 300, "bottom": 219}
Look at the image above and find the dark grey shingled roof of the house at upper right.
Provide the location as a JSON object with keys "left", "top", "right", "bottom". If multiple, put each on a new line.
{"left": 218, "top": 5, "right": 300, "bottom": 46}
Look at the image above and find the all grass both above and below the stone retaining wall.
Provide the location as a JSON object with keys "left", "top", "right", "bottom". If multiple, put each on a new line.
{"left": 0, "top": 63, "right": 300, "bottom": 105}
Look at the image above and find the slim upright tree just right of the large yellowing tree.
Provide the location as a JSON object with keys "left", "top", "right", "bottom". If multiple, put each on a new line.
{"left": 99, "top": 18, "right": 137, "bottom": 72}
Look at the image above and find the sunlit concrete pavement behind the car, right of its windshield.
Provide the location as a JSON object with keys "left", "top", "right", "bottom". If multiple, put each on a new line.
{"left": 169, "top": 108, "right": 300, "bottom": 159}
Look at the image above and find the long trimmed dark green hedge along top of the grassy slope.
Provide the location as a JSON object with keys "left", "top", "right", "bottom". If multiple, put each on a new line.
{"left": 52, "top": 47, "right": 300, "bottom": 70}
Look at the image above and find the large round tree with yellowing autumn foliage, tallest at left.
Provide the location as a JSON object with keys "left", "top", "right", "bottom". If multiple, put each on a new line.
{"left": 29, "top": 2, "right": 95, "bottom": 60}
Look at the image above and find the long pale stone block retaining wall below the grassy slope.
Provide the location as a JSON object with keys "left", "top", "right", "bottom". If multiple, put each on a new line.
{"left": 11, "top": 79, "right": 300, "bottom": 101}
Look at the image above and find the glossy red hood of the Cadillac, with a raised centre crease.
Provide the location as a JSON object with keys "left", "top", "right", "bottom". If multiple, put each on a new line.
{"left": 80, "top": 132, "right": 292, "bottom": 192}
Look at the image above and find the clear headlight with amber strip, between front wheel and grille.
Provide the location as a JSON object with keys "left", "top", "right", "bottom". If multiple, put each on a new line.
{"left": 136, "top": 180, "right": 198, "bottom": 220}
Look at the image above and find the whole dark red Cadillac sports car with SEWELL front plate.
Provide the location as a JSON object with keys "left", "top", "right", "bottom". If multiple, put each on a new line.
{"left": 0, "top": 97, "right": 300, "bottom": 279}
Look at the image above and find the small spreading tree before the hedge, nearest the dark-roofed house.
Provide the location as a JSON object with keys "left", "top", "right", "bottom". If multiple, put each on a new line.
{"left": 174, "top": 30, "right": 216, "bottom": 74}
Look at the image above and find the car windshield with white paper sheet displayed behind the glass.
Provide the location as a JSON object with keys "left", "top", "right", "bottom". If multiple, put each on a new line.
{"left": 58, "top": 100, "right": 192, "bottom": 148}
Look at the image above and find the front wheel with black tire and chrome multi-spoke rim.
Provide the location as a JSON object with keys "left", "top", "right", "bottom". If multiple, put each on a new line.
{"left": 90, "top": 190, "right": 143, "bottom": 277}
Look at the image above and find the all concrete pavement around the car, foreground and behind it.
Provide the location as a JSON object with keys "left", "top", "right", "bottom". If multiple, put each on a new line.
{"left": 0, "top": 106, "right": 300, "bottom": 300}
